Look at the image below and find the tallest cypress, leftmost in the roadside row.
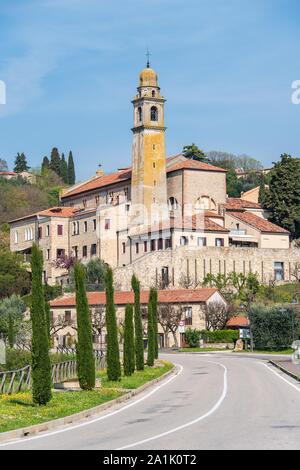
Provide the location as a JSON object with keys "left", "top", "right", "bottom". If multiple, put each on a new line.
{"left": 30, "top": 244, "right": 51, "bottom": 405}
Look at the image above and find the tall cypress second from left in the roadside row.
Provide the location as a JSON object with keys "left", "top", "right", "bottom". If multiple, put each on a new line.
{"left": 74, "top": 263, "right": 96, "bottom": 390}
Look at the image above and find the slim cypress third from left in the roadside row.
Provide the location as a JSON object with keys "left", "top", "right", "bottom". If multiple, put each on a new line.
{"left": 105, "top": 268, "right": 121, "bottom": 382}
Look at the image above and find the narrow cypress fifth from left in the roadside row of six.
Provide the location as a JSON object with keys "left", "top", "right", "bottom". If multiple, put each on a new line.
{"left": 131, "top": 274, "right": 144, "bottom": 370}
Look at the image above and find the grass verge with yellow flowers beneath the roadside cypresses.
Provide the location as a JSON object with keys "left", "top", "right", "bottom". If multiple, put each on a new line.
{"left": 0, "top": 361, "right": 173, "bottom": 432}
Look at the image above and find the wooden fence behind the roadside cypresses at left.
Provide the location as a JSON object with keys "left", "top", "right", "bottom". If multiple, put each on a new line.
{"left": 0, "top": 354, "right": 106, "bottom": 395}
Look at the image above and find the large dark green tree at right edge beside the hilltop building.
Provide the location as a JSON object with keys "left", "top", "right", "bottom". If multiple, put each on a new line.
{"left": 266, "top": 154, "right": 300, "bottom": 238}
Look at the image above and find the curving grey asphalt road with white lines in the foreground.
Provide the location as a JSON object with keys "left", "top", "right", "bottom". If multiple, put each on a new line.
{"left": 0, "top": 354, "right": 300, "bottom": 450}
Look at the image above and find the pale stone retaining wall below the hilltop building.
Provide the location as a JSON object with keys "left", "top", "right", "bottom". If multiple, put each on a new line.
{"left": 114, "top": 247, "right": 300, "bottom": 290}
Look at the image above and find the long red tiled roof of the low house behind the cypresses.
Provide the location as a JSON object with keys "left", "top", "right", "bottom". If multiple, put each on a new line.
{"left": 50, "top": 288, "right": 218, "bottom": 308}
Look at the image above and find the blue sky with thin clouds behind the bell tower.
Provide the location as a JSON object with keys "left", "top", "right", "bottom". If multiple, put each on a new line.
{"left": 0, "top": 0, "right": 300, "bottom": 180}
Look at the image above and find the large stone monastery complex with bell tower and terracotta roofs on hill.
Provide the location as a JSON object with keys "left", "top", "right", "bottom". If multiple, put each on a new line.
{"left": 10, "top": 64, "right": 300, "bottom": 289}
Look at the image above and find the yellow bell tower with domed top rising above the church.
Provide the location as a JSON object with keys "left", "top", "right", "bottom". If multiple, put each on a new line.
{"left": 131, "top": 61, "right": 167, "bottom": 224}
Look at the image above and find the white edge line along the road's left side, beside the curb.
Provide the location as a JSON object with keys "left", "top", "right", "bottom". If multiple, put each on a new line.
{"left": 0, "top": 364, "right": 183, "bottom": 447}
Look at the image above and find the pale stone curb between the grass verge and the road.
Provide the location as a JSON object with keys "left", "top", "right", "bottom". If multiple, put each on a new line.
{"left": 0, "top": 365, "right": 180, "bottom": 443}
